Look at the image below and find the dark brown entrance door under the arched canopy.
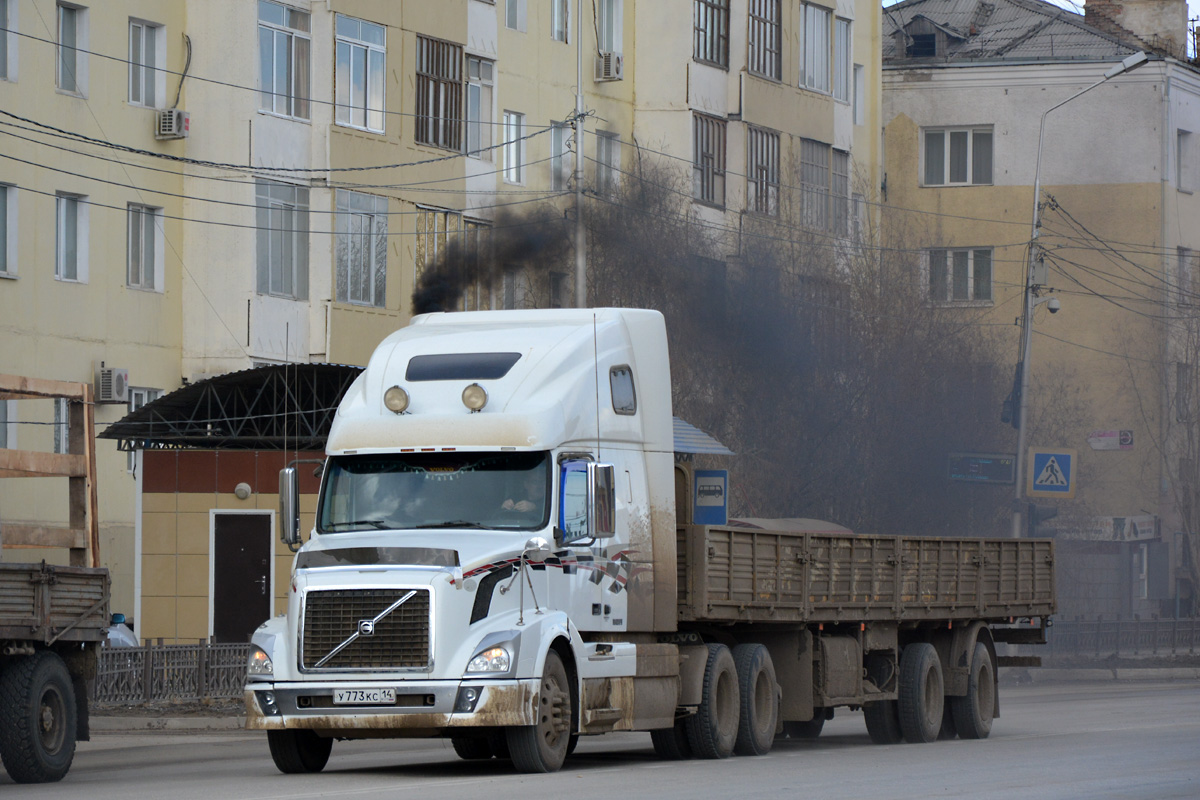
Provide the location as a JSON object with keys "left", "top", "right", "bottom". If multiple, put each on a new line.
{"left": 212, "top": 513, "right": 271, "bottom": 642}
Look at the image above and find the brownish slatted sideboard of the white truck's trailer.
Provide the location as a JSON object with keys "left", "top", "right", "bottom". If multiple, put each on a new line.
{"left": 678, "top": 525, "right": 1055, "bottom": 622}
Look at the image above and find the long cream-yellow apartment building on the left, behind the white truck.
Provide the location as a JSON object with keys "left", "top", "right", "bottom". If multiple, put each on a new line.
{"left": 0, "top": 0, "right": 882, "bottom": 639}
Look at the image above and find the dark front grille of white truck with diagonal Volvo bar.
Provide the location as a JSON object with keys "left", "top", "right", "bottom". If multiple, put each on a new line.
{"left": 300, "top": 589, "right": 430, "bottom": 669}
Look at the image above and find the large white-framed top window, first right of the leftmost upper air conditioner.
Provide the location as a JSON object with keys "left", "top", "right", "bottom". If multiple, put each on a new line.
{"left": 258, "top": 0, "right": 311, "bottom": 120}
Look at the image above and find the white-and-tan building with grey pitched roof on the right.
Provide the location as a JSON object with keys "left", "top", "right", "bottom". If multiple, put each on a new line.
{"left": 883, "top": 0, "right": 1200, "bottom": 618}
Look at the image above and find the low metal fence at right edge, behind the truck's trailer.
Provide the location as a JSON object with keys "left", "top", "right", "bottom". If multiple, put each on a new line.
{"left": 1030, "top": 619, "right": 1200, "bottom": 660}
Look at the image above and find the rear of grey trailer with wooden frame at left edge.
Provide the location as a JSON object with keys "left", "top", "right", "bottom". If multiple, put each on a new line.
{"left": 0, "top": 375, "right": 109, "bottom": 783}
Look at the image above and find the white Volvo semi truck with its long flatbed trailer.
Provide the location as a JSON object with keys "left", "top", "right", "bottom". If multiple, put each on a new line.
{"left": 245, "top": 308, "right": 1055, "bottom": 772}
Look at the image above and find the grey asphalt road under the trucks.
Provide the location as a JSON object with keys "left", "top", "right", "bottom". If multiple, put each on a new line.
{"left": 0, "top": 681, "right": 1200, "bottom": 800}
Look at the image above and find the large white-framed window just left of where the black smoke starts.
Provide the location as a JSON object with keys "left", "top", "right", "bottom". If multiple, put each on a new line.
{"left": 336, "top": 190, "right": 388, "bottom": 308}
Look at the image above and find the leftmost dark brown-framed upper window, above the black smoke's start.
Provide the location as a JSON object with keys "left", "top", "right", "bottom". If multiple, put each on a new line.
{"left": 416, "top": 36, "right": 462, "bottom": 150}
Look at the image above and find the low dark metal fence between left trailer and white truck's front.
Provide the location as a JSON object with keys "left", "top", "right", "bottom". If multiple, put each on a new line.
{"left": 95, "top": 642, "right": 250, "bottom": 703}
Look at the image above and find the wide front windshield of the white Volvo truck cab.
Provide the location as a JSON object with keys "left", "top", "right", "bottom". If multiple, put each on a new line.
{"left": 317, "top": 452, "right": 551, "bottom": 534}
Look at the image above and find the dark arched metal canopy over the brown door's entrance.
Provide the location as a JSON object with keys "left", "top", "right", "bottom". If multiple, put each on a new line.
{"left": 100, "top": 363, "right": 362, "bottom": 451}
